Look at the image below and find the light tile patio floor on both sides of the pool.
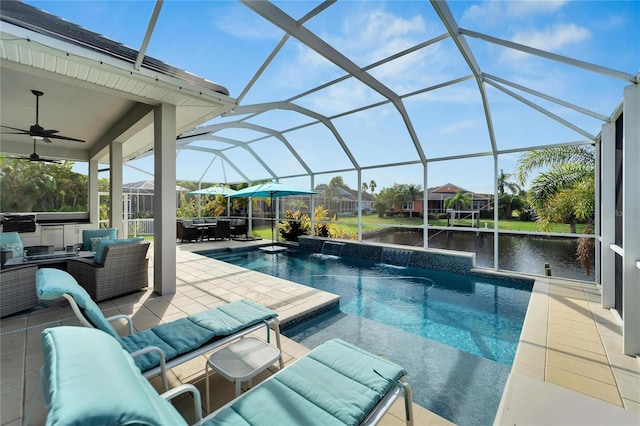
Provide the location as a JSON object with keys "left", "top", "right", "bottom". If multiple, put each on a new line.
{"left": 0, "top": 241, "right": 640, "bottom": 426}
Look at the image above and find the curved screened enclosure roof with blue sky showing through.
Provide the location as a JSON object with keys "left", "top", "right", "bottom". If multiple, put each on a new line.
{"left": 6, "top": 1, "right": 640, "bottom": 192}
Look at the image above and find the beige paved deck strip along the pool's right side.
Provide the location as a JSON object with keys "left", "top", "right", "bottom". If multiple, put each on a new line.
{"left": 494, "top": 277, "right": 640, "bottom": 425}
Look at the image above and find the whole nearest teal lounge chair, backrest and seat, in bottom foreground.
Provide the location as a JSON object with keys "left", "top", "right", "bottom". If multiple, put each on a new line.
{"left": 40, "top": 327, "right": 413, "bottom": 426}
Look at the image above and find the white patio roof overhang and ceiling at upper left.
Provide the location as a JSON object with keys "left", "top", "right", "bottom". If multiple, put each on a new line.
{"left": 0, "top": 1, "right": 236, "bottom": 163}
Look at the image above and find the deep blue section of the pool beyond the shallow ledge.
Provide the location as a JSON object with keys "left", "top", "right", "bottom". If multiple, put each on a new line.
{"left": 208, "top": 249, "right": 531, "bottom": 365}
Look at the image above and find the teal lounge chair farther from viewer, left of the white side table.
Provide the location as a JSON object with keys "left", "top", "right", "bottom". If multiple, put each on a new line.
{"left": 36, "top": 268, "right": 284, "bottom": 390}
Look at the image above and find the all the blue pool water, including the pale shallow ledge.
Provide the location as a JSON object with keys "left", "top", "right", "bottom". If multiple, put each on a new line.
{"left": 207, "top": 249, "right": 531, "bottom": 425}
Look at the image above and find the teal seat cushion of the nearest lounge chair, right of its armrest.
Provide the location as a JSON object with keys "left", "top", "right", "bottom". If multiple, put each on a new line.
{"left": 206, "top": 339, "right": 406, "bottom": 426}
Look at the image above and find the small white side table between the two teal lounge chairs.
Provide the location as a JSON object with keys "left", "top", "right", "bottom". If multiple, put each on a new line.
{"left": 204, "top": 337, "right": 282, "bottom": 413}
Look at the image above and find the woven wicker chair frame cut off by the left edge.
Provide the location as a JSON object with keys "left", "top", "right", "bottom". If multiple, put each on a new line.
{"left": 0, "top": 265, "right": 38, "bottom": 317}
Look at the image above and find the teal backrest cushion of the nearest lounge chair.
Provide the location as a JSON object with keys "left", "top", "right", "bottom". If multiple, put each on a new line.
{"left": 42, "top": 326, "right": 186, "bottom": 425}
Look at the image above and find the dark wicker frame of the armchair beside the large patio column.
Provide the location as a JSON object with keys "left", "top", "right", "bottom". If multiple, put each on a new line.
{"left": 67, "top": 242, "right": 149, "bottom": 302}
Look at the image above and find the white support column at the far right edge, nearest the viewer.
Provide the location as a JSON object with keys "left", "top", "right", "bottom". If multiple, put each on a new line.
{"left": 622, "top": 85, "right": 640, "bottom": 356}
